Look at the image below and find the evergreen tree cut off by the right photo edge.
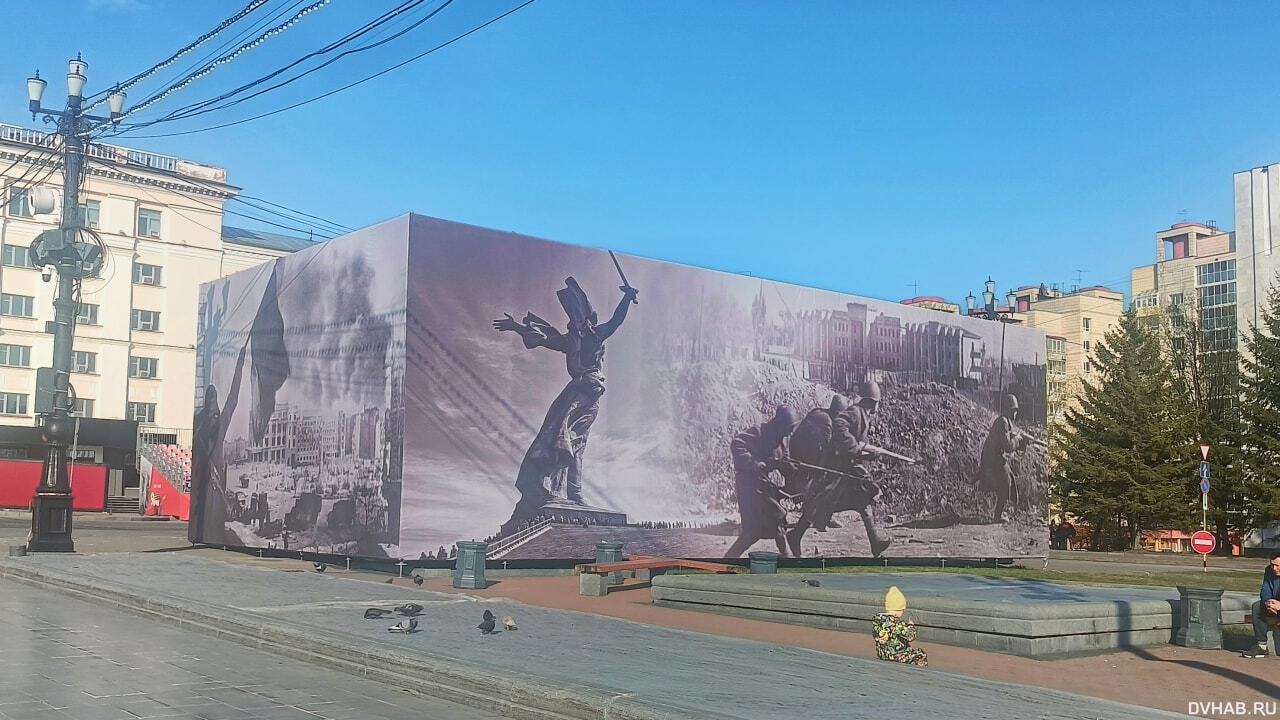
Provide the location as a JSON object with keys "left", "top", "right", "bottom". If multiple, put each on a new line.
{"left": 1239, "top": 278, "right": 1280, "bottom": 529}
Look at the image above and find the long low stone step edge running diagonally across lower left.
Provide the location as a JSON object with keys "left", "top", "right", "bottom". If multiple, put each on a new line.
{"left": 0, "top": 561, "right": 701, "bottom": 720}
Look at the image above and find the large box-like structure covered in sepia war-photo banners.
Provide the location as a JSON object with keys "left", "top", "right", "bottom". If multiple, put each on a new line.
{"left": 191, "top": 215, "right": 1047, "bottom": 560}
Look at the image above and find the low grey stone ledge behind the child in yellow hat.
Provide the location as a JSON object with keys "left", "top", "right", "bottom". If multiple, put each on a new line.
{"left": 652, "top": 575, "right": 1248, "bottom": 657}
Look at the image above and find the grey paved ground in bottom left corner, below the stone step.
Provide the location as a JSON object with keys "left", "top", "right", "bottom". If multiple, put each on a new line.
{"left": 0, "top": 576, "right": 519, "bottom": 720}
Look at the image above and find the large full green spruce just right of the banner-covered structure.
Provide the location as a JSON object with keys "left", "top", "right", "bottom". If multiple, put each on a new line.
{"left": 1051, "top": 310, "right": 1198, "bottom": 550}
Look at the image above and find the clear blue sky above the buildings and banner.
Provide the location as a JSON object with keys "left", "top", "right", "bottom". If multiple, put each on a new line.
{"left": 0, "top": 0, "right": 1280, "bottom": 301}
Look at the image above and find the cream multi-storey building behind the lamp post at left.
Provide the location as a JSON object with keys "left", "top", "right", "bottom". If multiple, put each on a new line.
{"left": 0, "top": 124, "right": 310, "bottom": 442}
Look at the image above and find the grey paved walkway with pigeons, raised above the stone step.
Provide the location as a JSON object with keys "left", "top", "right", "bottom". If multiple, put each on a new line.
{"left": 0, "top": 553, "right": 1174, "bottom": 720}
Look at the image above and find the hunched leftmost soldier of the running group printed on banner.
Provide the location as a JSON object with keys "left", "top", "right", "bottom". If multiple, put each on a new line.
{"left": 724, "top": 406, "right": 796, "bottom": 557}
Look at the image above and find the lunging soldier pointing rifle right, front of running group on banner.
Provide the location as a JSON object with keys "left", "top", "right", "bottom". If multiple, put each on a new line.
{"left": 787, "top": 380, "right": 910, "bottom": 557}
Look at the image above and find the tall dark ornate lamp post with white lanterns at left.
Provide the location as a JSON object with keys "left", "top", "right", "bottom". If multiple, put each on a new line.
{"left": 27, "top": 55, "right": 124, "bottom": 552}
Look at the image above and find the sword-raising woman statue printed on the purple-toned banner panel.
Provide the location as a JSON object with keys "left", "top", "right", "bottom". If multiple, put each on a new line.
{"left": 493, "top": 252, "right": 640, "bottom": 534}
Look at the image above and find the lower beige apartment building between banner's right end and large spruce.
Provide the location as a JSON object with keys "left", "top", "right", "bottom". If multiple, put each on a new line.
{"left": 1014, "top": 286, "right": 1124, "bottom": 423}
